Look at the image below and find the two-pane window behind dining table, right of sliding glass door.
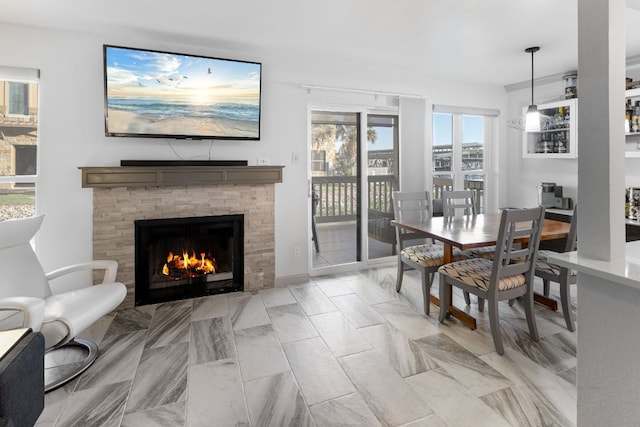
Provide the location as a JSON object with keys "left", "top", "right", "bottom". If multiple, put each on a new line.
{"left": 432, "top": 106, "right": 495, "bottom": 212}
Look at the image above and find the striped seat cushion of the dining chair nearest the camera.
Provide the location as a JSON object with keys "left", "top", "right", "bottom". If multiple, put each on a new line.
{"left": 438, "top": 258, "right": 526, "bottom": 291}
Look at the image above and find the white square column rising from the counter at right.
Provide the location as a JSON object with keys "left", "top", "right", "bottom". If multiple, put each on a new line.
{"left": 578, "top": 0, "right": 625, "bottom": 261}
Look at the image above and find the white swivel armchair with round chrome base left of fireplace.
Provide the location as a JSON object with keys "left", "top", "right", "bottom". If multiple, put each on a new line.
{"left": 0, "top": 215, "right": 127, "bottom": 391}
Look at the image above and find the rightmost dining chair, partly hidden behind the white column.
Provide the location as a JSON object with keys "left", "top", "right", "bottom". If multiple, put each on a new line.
{"left": 535, "top": 204, "right": 578, "bottom": 332}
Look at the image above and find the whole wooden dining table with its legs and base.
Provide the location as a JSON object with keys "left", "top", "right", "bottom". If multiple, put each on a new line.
{"left": 391, "top": 213, "right": 570, "bottom": 329}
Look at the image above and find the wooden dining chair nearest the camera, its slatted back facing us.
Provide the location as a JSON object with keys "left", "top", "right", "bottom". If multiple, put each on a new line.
{"left": 438, "top": 206, "right": 544, "bottom": 355}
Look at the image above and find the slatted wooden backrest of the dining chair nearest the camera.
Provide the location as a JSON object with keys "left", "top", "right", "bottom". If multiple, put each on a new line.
{"left": 492, "top": 206, "right": 544, "bottom": 294}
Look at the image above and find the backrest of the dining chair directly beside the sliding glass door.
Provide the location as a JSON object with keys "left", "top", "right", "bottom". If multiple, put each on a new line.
{"left": 391, "top": 191, "right": 432, "bottom": 249}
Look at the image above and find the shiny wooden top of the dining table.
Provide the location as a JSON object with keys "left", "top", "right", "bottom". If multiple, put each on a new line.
{"left": 391, "top": 213, "right": 570, "bottom": 250}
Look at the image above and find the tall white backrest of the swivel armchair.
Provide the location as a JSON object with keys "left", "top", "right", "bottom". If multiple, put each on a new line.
{"left": 0, "top": 215, "right": 51, "bottom": 298}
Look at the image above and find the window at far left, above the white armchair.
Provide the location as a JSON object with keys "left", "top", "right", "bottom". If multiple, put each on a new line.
{"left": 0, "top": 67, "right": 38, "bottom": 220}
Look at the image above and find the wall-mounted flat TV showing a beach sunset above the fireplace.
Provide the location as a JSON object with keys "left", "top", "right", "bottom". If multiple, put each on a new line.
{"left": 104, "top": 45, "right": 262, "bottom": 140}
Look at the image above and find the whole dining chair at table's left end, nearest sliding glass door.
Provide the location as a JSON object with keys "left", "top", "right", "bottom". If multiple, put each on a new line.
{"left": 392, "top": 191, "right": 466, "bottom": 315}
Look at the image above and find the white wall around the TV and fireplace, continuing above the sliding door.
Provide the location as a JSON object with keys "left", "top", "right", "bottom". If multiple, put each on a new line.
{"left": 0, "top": 24, "right": 510, "bottom": 278}
